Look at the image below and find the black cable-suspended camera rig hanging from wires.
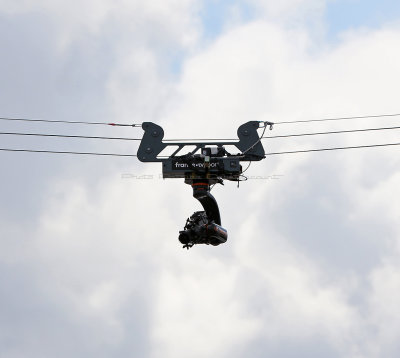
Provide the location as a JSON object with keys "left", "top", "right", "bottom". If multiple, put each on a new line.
{"left": 137, "top": 121, "right": 273, "bottom": 249}
